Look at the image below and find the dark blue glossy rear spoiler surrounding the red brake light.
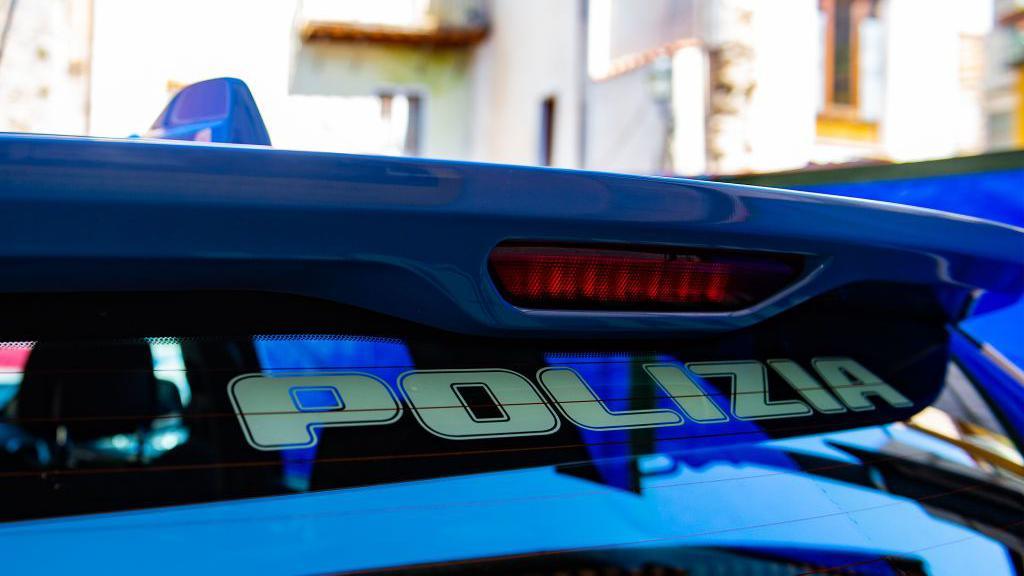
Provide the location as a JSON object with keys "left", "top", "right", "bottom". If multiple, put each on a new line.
{"left": 0, "top": 134, "right": 1024, "bottom": 335}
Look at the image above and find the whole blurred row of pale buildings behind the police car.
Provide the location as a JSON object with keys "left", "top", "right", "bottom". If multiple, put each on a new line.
{"left": 0, "top": 0, "right": 1024, "bottom": 175}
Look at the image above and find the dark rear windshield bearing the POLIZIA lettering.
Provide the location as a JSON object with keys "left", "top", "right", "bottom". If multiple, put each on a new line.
{"left": 0, "top": 287, "right": 1012, "bottom": 569}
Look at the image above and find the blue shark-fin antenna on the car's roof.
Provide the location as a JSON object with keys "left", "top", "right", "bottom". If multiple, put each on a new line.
{"left": 144, "top": 78, "right": 270, "bottom": 146}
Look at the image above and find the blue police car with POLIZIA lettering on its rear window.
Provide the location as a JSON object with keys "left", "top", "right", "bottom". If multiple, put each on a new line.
{"left": 0, "top": 79, "right": 1024, "bottom": 575}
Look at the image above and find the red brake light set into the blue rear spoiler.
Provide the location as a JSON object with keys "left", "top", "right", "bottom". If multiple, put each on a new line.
{"left": 489, "top": 244, "right": 801, "bottom": 312}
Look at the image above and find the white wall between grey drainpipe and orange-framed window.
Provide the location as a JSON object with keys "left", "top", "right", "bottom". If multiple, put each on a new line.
{"left": 587, "top": 0, "right": 820, "bottom": 175}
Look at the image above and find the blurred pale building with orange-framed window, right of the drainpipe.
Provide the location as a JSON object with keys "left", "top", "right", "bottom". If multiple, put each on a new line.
{"left": 590, "top": 0, "right": 992, "bottom": 173}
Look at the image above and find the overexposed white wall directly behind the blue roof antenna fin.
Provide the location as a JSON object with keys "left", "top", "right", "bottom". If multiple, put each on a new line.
{"left": 90, "top": 0, "right": 295, "bottom": 138}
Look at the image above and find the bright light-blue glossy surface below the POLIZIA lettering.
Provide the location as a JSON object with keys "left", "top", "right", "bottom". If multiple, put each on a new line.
{"left": 0, "top": 426, "right": 1014, "bottom": 575}
